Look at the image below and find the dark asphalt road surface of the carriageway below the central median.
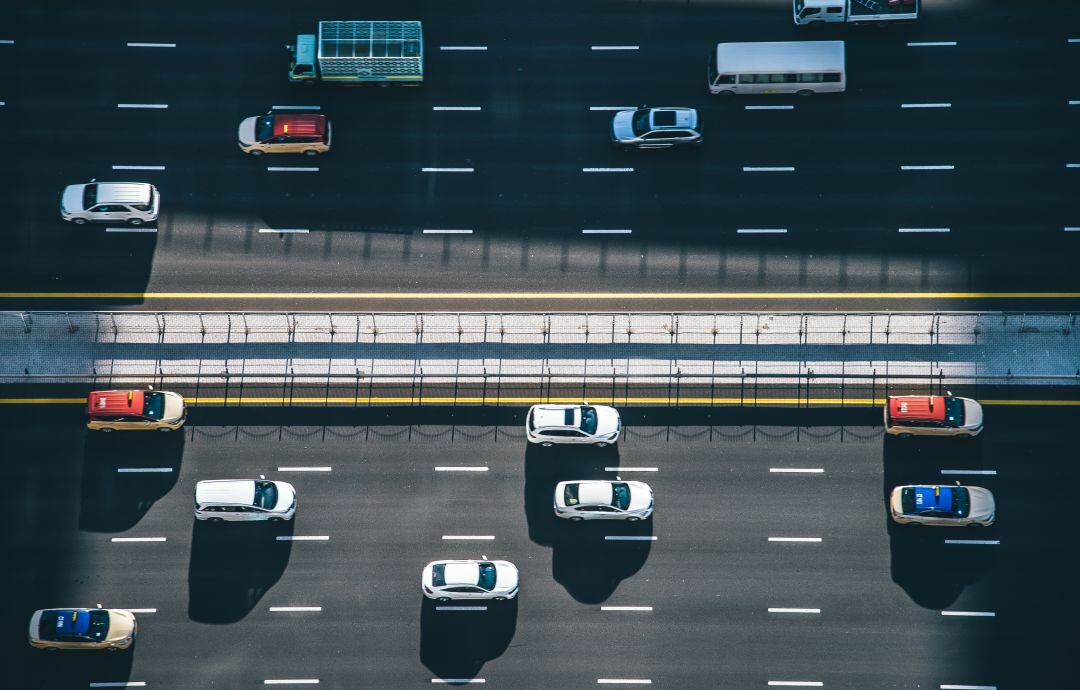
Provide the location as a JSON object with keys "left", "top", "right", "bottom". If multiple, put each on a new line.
{"left": 0, "top": 408, "right": 1078, "bottom": 689}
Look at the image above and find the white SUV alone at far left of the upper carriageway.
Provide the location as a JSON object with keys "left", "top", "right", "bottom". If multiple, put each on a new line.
{"left": 60, "top": 180, "right": 161, "bottom": 226}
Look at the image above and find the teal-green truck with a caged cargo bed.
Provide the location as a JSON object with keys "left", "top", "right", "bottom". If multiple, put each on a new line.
{"left": 287, "top": 22, "right": 423, "bottom": 85}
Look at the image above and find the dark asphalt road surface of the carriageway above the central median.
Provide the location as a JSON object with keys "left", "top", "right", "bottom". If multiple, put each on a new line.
{"left": 0, "top": 0, "right": 1080, "bottom": 310}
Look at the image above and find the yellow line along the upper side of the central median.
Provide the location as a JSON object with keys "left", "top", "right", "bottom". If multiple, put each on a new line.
{"left": 0, "top": 292, "right": 1080, "bottom": 301}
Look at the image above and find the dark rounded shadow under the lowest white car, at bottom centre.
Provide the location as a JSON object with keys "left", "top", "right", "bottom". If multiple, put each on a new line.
{"left": 420, "top": 598, "right": 517, "bottom": 682}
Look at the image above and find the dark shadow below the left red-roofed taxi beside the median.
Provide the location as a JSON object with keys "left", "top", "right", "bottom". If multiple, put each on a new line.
{"left": 79, "top": 431, "right": 185, "bottom": 532}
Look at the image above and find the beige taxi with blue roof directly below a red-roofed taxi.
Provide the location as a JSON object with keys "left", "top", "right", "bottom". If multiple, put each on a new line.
{"left": 889, "top": 484, "right": 996, "bottom": 527}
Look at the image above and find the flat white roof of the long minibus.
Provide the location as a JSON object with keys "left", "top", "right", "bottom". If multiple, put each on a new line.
{"left": 716, "top": 41, "right": 843, "bottom": 75}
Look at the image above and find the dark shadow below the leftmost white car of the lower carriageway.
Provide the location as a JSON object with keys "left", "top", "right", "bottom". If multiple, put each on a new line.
{"left": 188, "top": 519, "right": 293, "bottom": 624}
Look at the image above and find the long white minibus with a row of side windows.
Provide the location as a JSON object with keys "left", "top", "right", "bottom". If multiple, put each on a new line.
{"left": 708, "top": 41, "right": 848, "bottom": 96}
